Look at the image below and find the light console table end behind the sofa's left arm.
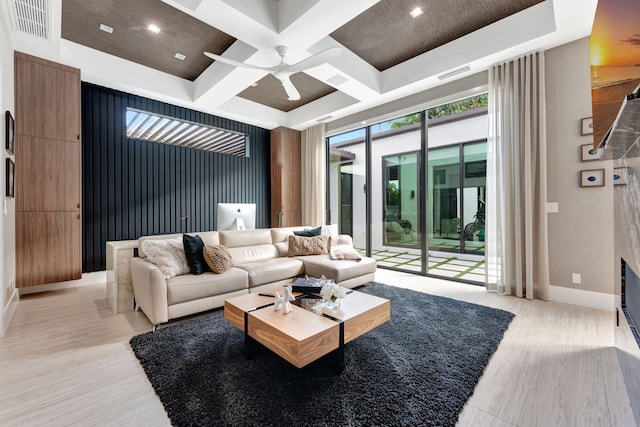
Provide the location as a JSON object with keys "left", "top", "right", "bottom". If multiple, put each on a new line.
{"left": 107, "top": 240, "right": 138, "bottom": 313}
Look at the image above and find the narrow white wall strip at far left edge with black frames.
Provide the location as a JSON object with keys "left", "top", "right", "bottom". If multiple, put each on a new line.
{"left": 0, "top": 10, "right": 18, "bottom": 336}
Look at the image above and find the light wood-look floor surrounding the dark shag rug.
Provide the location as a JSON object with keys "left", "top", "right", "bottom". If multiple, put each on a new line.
{"left": 0, "top": 269, "right": 640, "bottom": 427}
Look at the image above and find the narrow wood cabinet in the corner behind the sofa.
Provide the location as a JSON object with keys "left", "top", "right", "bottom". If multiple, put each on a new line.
{"left": 271, "top": 127, "right": 302, "bottom": 227}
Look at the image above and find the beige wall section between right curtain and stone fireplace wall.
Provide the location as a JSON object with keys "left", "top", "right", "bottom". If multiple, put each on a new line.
{"left": 545, "top": 38, "right": 615, "bottom": 310}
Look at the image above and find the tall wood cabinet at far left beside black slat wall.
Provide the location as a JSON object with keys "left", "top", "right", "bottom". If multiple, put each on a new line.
{"left": 15, "top": 52, "right": 82, "bottom": 287}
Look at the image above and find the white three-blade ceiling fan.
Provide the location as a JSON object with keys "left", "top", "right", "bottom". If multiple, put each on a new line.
{"left": 204, "top": 46, "right": 342, "bottom": 101}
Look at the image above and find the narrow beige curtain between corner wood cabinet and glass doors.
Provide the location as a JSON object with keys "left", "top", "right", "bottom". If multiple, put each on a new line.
{"left": 300, "top": 124, "right": 327, "bottom": 226}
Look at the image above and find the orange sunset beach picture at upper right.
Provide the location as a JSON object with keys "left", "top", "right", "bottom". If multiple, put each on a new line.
{"left": 590, "top": 0, "right": 640, "bottom": 146}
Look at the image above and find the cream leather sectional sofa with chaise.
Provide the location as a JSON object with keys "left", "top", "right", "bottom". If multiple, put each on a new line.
{"left": 130, "top": 227, "right": 376, "bottom": 326}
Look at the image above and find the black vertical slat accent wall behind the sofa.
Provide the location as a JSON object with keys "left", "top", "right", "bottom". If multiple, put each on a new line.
{"left": 82, "top": 82, "right": 271, "bottom": 272}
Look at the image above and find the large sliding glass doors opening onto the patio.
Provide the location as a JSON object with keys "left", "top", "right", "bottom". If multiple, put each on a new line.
{"left": 327, "top": 95, "right": 487, "bottom": 282}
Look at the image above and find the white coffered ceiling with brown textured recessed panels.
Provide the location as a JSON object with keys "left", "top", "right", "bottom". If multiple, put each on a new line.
{"left": 0, "top": 0, "right": 597, "bottom": 129}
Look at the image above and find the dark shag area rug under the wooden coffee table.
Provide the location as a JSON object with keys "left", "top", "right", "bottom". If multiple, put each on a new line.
{"left": 131, "top": 283, "right": 514, "bottom": 426}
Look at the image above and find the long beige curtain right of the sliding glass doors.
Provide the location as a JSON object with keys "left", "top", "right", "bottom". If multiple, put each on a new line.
{"left": 486, "top": 52, "right": 549, "bottom": 299}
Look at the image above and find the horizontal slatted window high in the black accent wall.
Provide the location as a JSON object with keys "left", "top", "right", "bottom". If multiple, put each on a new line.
{"left": 127, "top": 108, "right": 248, "bottom": 157}
